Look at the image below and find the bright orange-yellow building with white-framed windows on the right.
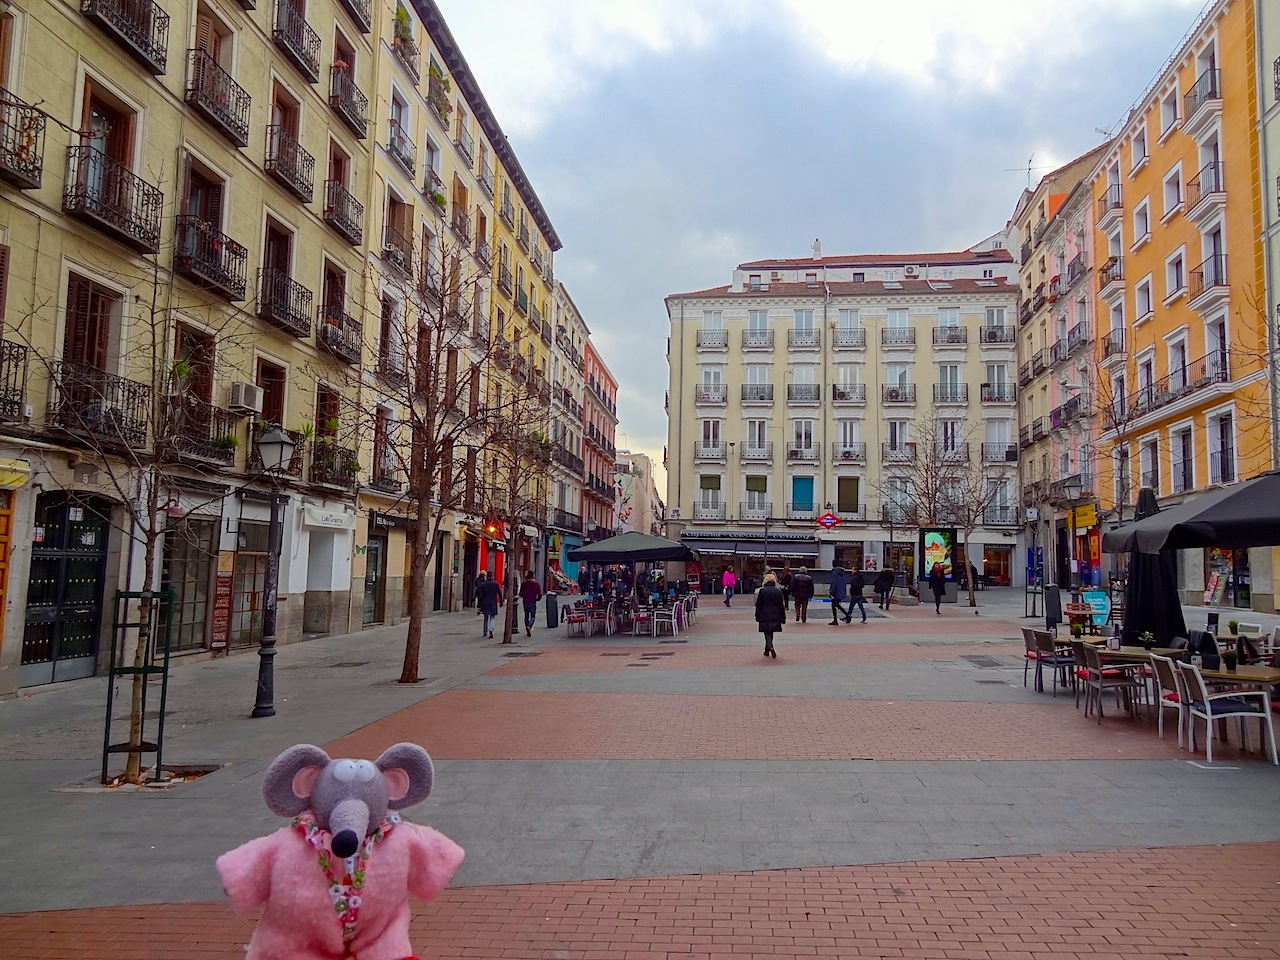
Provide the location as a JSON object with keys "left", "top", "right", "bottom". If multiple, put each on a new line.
{"left": 1091, "top": 0, "right": 1275, "bottom": 611}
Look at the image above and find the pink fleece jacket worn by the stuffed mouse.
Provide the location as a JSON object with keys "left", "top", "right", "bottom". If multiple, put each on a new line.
{"left": 218, "top": 822, "right": 462, "bottom": 960}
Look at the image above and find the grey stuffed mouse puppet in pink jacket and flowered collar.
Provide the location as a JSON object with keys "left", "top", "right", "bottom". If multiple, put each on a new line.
{"left": 218, "top": 744, "right": 462, "bottom": 960}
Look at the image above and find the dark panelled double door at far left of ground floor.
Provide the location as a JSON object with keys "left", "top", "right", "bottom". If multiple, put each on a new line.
{"left": 18, "top": 492, "right": 110, "bottom": 686}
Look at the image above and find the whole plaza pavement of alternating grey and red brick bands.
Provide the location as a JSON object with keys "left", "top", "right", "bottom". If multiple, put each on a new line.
{"left": 0, "top": 590, "right": 1280, "bottom": 960}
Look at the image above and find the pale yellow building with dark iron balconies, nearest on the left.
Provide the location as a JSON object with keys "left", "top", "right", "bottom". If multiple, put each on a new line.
{"left": 0, "top": 0, "right": 374, "bottom": 695}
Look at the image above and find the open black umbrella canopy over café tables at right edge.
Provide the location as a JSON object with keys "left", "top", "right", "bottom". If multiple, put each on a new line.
{"left": 1102, "top": 472, "right": 1280, "bottom": 553}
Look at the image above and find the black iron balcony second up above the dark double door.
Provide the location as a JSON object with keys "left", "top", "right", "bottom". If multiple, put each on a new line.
{"left": 63, "top": 146, "right": 164, "bottom": 253}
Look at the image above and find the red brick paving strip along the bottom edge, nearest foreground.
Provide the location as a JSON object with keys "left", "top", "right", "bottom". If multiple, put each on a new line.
{"left": 0, "top": 844, "right": 1280, "bottom": 960}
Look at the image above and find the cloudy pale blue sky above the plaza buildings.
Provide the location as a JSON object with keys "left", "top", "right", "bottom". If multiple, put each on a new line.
{"left": 438, "top": 0, "right": 1203, "bottom": 491}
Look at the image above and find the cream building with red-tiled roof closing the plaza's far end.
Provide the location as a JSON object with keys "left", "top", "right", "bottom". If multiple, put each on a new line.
{"left": 667, "top": 245, "right": 1021, "bottom": 582}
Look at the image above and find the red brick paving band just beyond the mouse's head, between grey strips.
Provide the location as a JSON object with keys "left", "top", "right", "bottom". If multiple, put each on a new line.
{"left": 329, "top": 690, "right": 1187, "bottom": 760}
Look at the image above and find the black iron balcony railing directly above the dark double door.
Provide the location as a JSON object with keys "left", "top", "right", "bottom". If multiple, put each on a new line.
{"left": 49, "top": 361, "right": 151, "bottom": 449}
